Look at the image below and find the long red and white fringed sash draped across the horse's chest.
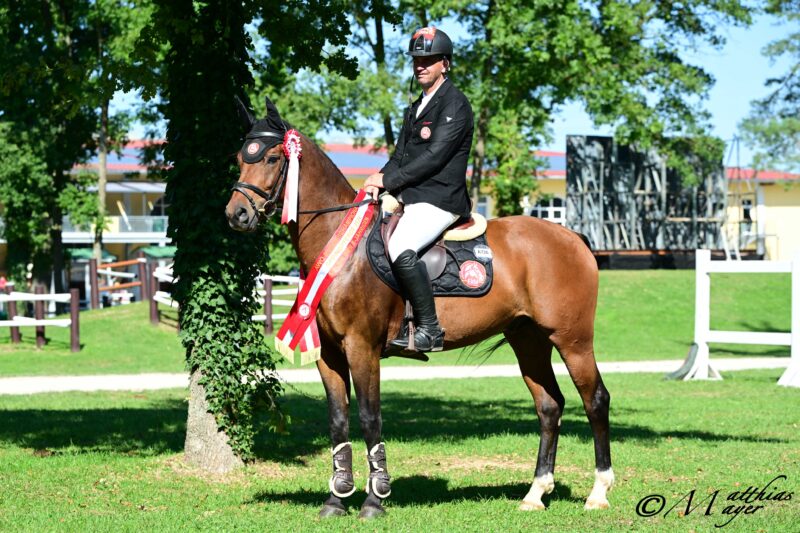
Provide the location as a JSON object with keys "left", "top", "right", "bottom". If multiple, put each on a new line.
{"left": 275, "top": 189, "right": 375, "bottom": 364}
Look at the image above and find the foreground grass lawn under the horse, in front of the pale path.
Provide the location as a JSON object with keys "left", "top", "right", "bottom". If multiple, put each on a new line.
{"left": 0, "top": 370, "right": 800, "bottom": 532}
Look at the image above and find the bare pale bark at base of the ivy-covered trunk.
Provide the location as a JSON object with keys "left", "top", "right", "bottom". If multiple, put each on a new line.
{"left": 184, "top": 369, "right": 244, "bottom": 474}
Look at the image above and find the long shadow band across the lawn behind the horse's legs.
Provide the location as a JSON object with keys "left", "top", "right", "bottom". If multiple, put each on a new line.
{"left": 0, "top": 393, "right": 783, "bottom": 464}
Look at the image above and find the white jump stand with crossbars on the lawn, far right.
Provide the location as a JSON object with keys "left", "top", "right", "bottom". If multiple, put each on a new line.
{"left": 678, "top": 250, "right": 800, "bottom": 387}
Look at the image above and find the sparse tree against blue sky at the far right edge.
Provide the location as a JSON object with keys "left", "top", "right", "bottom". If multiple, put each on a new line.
{"left": 740, "top": 0, "right": 800, "bottom": 172}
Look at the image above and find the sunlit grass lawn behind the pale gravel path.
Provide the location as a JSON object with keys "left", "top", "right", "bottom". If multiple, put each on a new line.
{"left": 0, "top": 270, "right": 790, "bottom": 376}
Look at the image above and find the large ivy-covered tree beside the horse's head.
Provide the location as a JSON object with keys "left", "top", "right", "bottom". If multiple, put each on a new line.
{"left": 139, "top": 0, "right": 353, "bottom": 470}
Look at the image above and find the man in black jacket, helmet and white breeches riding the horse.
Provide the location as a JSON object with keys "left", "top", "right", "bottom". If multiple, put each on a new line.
{"left": 364, "top": 27, "right": 473, "bottom": 352}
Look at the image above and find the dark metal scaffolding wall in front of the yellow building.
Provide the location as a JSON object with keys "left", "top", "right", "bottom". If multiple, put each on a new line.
{"left": 566, "top": 135, "right": 727, "bottom": 250}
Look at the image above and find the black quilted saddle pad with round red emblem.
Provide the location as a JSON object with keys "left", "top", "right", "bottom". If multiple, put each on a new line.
{"left": 367, "top": 217, "right": 492, "bottom": 296}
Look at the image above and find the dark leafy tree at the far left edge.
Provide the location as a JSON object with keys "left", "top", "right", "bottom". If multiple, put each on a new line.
{"left": 0, "top": 1, "right": 97, "bottom": 292}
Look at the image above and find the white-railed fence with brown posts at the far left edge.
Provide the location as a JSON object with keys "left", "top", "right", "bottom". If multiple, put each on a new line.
{"left": 0, "top": 289, "right": 80, "bottom": 352}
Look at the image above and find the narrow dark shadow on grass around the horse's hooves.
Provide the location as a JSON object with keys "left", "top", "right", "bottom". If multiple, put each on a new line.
{"left": 247, "top": 476, "right": 583, "bottom": 509}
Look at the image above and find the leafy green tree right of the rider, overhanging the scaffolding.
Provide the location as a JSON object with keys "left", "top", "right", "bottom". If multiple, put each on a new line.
{"left": 401, "top": 0, "right": 750, "bottom": 212}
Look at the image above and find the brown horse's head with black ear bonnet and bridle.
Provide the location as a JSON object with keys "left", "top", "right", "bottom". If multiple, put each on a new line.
{"left": 225, "top": 98, "right": 288, "bottom": 231}
